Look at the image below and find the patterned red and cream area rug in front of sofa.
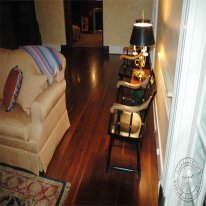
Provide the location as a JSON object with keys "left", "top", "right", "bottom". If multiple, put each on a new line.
{"left": 0, "top": 164, "right": 71, "bottom": 206}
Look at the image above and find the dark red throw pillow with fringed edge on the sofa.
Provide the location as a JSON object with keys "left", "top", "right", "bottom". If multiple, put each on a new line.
{"left": 3, "top": 66, "right": 23, "bottom": 111}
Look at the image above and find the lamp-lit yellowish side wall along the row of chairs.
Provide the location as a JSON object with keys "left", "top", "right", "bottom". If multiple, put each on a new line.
{"left": 154, "top": 0, "right": 183, "bottom": 174}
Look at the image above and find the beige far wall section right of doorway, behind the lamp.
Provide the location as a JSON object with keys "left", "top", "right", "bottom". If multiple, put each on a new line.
{"left": 103, "top": 0, "right": 153, "bottom": 53}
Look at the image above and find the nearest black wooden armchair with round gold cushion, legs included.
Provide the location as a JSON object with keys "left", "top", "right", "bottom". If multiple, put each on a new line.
{"left": 106, "top": 73, "right": 157, "bottom": 179}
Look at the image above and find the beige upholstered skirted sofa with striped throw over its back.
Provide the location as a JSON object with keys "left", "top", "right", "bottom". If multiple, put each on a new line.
{"left": 0, "top": 49, "right": 70, "bottom": 175}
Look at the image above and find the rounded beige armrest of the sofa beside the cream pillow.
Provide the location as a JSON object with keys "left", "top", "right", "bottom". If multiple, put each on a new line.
{"left": 31, "top": 80, "right": 66, "bottom": 121}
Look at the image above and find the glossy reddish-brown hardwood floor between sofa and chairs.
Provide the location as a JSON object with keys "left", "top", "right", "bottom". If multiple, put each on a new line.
{"left": 46, "top": 48, "right": 158, "bottom": 206}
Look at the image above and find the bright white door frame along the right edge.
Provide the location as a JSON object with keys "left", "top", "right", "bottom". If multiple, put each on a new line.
{"left": 161, "top": 0, "right": 206, "bottom": 205}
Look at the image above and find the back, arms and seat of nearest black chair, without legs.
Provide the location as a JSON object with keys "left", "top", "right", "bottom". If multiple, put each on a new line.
{"left": 108, "top": 76, "right": 157, "bottom": 140}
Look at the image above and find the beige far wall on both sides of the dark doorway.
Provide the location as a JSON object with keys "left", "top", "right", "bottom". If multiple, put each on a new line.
{"left": 35, "top": 0, "right": 153, "bottom": 53}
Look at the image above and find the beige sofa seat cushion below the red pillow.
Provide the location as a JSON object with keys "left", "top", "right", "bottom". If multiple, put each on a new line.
{"left": 0, "top": 104, "right": 31, "bottom": 141}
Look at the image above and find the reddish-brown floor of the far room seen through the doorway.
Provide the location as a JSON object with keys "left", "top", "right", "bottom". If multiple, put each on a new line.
{"left": 73, "top": 32, "right": 102, "bottom": 47}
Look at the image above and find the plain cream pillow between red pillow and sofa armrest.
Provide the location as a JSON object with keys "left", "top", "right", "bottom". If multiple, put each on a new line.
{"left": 17, "top": 70, "right": 48, "bottom": 115}
